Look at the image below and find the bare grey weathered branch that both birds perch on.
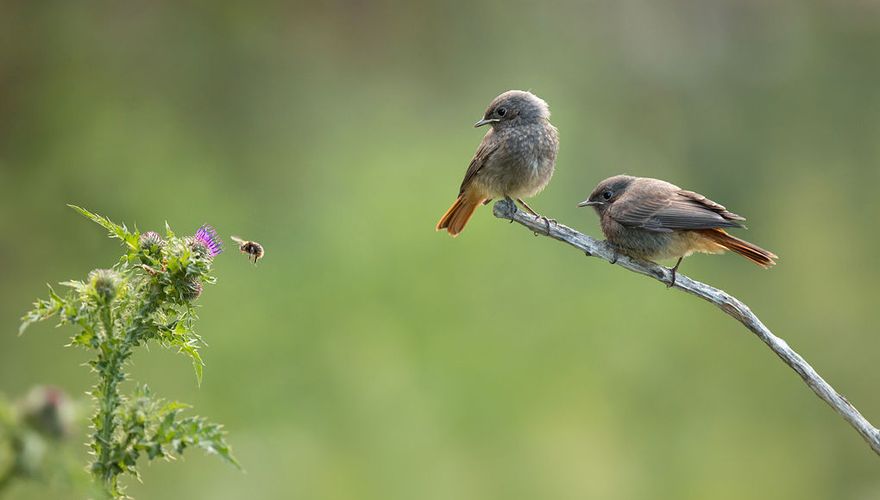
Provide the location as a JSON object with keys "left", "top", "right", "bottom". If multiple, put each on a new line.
{"left": 493, "top": 200, "right": 880, "bottom": 455}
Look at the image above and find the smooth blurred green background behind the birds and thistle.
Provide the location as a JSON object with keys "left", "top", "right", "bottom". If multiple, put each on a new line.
{"left": 0, "top": 0, "right": 880, "bottom": 500}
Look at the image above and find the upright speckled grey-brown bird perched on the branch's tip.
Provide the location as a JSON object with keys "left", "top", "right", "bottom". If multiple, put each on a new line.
{"left": 437, "top": 90, "right": 559, "bottom": 236}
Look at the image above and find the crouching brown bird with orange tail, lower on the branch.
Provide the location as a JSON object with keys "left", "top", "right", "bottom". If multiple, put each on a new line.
{"left": 578, "top": 175, "right": 778, "bottom": 286}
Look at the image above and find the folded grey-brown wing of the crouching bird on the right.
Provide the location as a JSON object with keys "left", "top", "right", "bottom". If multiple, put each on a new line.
{"left": 611, "top": 190, "right": 745, "bottom": 232}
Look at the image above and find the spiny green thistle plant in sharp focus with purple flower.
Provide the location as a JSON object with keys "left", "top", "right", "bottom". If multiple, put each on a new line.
{"left": 20, "top": 205, "right": 238, "bottom": 499}
